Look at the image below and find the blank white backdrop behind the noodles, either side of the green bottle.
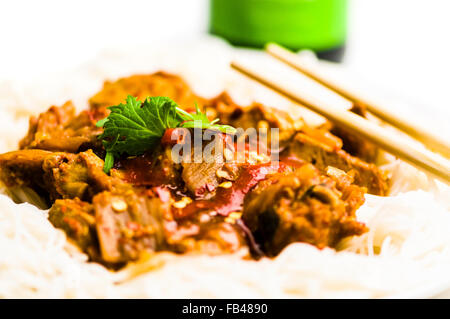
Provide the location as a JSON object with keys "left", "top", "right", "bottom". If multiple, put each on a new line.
{"left": 0, "top": 0, "right": 450, "bottom": 121}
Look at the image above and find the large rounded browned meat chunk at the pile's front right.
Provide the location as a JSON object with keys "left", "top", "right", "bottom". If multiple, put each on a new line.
{"left": 242, "top": 164, "right": 367, "bottom": 256}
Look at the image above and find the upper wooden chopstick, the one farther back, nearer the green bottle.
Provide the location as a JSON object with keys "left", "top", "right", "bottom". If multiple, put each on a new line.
{"left": 266, "top": 43, "right": 450, "bottom": 158}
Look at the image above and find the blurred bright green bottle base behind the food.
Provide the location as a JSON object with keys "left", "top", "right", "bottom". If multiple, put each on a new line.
{"left": 210, "top": 0, "right": 347, "bottom": 61}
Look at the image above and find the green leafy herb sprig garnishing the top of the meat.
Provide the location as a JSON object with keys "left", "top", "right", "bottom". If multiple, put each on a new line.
{"left": 96, "top": 95, "right": 235, "bottom": 173}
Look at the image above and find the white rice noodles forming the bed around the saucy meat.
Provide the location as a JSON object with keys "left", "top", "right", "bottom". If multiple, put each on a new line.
{"left": 0, "top": 40, "right": 450, "bottom": 298}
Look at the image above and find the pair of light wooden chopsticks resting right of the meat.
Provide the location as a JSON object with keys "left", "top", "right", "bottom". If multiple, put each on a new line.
{"left": 231, "top": 44, "right": 450, "bottom": 184}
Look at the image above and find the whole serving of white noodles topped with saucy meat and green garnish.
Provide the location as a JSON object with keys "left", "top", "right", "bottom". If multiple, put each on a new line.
{"left": 0, "top": 39, "right": 450, "bottom": 298}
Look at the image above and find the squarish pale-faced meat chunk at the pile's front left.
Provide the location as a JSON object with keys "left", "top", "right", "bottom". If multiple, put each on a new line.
{"left": 93, "top": 189, "right": 170, "bottom": 264}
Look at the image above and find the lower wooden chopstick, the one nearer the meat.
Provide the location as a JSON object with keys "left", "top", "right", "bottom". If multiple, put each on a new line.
{"left": 231, "top": 61, "right": 450, "bottom": 184}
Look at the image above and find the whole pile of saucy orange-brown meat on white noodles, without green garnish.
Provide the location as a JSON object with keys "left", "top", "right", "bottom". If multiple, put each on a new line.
{"left": 0, "top": 72, "right": 388, "bottom": 268}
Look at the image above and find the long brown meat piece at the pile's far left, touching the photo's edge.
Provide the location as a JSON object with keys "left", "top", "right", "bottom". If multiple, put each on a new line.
{"left": 0, "top": 149, "right": 124, "bottom": 202}
